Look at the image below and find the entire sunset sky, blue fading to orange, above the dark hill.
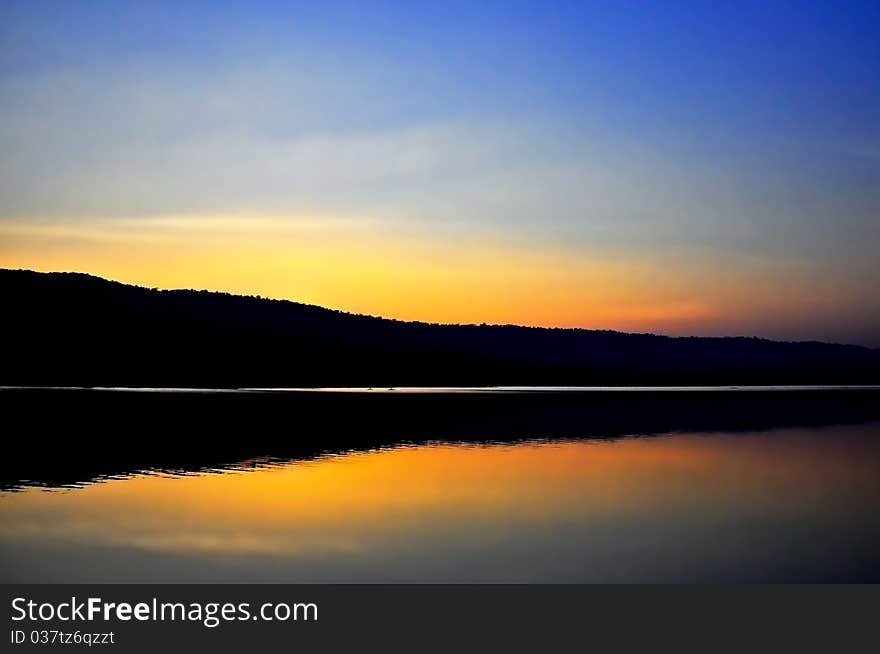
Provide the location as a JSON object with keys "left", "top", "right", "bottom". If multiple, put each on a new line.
{"left": 0, "top": 0, "right": 880, "bottom": 347}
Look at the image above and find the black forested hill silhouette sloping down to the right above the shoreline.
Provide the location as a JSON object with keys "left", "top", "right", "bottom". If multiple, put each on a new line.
{"left": 0, "top": 270, "right": 880, "bottom": 387}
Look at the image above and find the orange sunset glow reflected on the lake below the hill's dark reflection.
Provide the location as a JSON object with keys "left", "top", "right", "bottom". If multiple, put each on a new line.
{"left": 6, "top": 427, "right": 880, "bottom": 568}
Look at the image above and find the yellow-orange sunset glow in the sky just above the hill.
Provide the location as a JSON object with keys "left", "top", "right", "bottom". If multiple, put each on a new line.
{"left": 0, "top": 216, "right": 864, "bottom": 335}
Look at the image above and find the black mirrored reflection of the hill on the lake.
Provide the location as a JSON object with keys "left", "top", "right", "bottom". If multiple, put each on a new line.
{"left": 0, "top": 389, "right": 880, "bottom": 489}
